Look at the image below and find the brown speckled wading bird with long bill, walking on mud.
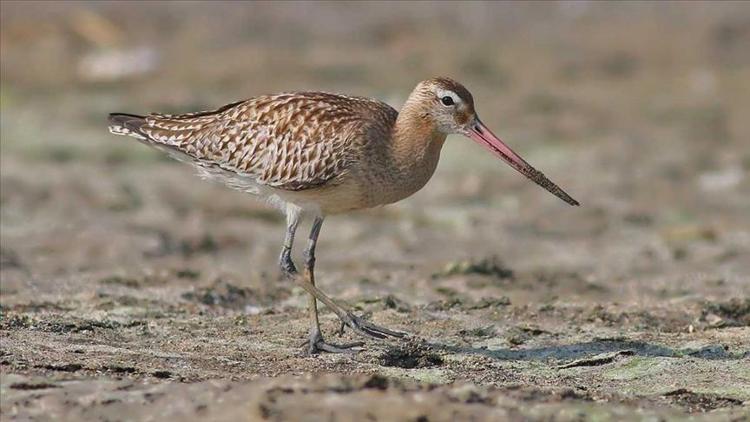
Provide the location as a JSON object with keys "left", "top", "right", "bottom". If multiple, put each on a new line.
{"left": 108, "top": 77, "right": 579, "bottom": 355}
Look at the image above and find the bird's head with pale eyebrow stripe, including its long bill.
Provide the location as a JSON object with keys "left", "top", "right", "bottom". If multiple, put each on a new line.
{"left": 409, "top": 77, "right": 579, "bottom": 205}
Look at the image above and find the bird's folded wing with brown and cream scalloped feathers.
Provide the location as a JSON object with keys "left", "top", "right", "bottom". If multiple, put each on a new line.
{"left": 138, "top": 92, "right": 397, "bottom": 190}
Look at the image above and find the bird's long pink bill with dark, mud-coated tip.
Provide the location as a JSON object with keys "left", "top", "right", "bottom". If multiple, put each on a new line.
{"left": 467, "top": 118, "right": 580, "bottom": 206}
